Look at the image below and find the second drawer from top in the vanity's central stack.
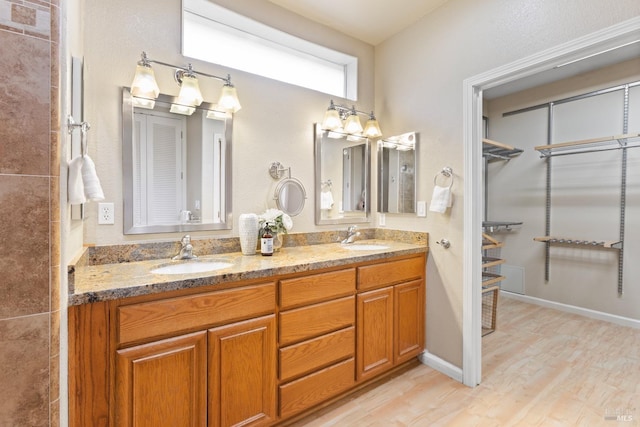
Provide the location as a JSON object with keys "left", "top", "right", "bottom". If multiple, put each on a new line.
{"left": 280, "top": 296, "right": 356, "bottom": 346}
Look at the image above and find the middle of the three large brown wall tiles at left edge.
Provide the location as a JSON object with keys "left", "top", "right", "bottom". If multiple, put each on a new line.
{"left": 0, "top": 175, "right": 50, "bottom": 319}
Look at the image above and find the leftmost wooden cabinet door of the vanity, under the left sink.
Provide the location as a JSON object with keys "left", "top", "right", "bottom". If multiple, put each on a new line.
{"left": 115, "top": 332, "right": 207, "bottom": 427}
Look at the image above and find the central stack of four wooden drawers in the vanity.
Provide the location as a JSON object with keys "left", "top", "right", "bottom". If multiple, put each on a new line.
{"left": 278, "top": 268, "right": 356, "bottom": 418}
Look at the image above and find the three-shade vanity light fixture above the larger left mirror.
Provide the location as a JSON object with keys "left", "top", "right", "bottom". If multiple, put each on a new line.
{"left": 131, "top": 52, "right": 242, "bottom": 115}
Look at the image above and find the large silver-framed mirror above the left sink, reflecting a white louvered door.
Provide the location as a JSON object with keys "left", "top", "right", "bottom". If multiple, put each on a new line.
{"left": 122, "top": 88, "right": 233, "bottom": 234}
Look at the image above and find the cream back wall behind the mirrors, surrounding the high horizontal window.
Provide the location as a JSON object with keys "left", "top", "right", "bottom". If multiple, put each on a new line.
{"left": 84, "top": 0, "right": 374, "bottom": 245}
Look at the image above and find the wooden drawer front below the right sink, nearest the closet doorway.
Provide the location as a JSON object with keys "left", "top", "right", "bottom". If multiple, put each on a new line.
{"left": 358, "top": 257, "right": 425, "bottom": 290}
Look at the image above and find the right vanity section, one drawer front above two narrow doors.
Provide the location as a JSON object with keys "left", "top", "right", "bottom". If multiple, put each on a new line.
{"left": 356, "top": 256, "right": 425, "bottom": 381}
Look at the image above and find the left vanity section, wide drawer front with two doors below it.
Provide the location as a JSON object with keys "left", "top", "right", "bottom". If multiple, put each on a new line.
{"left": 113, "top": 283, "right": 277, "bottom": 427}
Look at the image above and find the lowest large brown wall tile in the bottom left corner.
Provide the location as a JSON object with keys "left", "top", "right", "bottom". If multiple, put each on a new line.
{"left": 0, "top": 313, "right": 50, "bottom": 426}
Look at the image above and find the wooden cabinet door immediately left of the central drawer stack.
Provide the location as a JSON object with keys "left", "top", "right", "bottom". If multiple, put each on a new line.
{"left": 209, "top": 315, "right": 277, "bottom": 427}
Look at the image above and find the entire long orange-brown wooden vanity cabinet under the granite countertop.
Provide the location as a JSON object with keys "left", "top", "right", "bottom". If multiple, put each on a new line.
{"left": 69, "top": 253, "right": 425, "bottom": 427}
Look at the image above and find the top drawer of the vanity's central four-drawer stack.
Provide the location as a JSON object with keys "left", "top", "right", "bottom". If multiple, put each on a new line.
{"left": 280, "top": 268, "right": 356, "bottom": 309}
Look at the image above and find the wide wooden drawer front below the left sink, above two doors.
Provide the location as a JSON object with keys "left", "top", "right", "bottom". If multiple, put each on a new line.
{"left": 117, "top": 283, "right": 276, "bottom": 344}
